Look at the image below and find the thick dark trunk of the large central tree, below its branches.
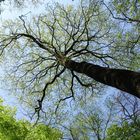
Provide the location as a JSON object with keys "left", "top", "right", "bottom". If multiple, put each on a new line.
{"left": 65, "top": 60, "right": 140, "bottom": 98}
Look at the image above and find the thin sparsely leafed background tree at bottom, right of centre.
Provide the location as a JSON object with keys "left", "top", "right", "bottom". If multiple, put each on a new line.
{"left": 63, "top": 102, "right": 114, "bottom": 140}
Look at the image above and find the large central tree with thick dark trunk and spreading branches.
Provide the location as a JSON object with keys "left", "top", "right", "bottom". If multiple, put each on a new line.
{"left": 0, "top": 0, "right": 140, "bottom": 119}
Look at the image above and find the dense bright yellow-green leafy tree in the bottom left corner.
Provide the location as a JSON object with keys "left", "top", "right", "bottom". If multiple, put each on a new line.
{"left": 0, "top": 100, "right": 62, "bottom": 140}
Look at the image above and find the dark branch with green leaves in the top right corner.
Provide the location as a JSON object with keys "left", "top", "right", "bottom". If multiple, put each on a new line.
{"left": 104, "top": 0, "right": 140, "bottom": 24}
